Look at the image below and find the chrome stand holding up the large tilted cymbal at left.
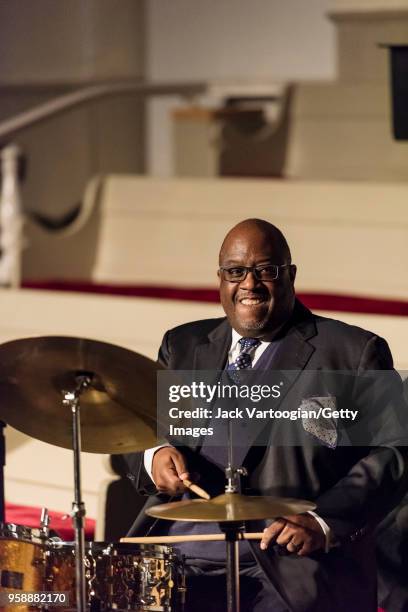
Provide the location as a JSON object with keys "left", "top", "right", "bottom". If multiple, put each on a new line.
{"left": 62, "top": 372, "right": 93, "bottom": 612}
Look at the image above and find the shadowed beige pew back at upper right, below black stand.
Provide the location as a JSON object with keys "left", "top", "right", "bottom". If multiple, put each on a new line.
{"left": 286, "top": 80, "right": 408, "bottom": 181}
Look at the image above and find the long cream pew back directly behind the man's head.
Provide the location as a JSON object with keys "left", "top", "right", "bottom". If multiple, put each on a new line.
{"left": 86, "top": 177, "right": 408, "bottom": 299}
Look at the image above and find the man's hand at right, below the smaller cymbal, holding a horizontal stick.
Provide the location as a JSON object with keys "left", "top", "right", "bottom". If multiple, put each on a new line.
{"left": 261, "top": 514, "right": 326, "bottom": 557}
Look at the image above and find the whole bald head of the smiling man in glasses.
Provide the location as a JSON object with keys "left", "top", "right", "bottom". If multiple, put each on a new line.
{"left": 218, "top": 219, "right": 296, "bottom": 340}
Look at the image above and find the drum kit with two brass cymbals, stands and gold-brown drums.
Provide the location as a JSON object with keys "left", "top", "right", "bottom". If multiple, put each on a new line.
{"left": 0, "top": 336, "right": 314, "bottom": 612}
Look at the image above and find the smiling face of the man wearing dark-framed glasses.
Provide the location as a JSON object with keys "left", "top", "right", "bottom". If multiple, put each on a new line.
{"left": 220, "top": 226, "right": 296, "bottom": 339}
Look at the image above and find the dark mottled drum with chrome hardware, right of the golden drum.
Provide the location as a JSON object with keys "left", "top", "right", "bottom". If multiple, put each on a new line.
{"left": 46, "top": 542, "right": 184, "bottom": 612}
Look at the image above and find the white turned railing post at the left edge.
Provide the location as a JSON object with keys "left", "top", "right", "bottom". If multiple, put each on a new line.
{"left": 0, "top": 144, "right": 24, "bottom": 289}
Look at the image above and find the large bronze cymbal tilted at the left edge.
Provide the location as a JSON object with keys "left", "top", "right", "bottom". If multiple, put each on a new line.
{"left": 0, "top": 336, "right": 160, "bottom": 454}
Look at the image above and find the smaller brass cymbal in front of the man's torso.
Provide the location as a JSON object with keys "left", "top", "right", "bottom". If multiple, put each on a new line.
{"left": 146, "top": 493, "right": 316, "bottom": 523}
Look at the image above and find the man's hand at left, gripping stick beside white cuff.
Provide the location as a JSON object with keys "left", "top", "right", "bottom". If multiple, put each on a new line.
{"left": 152, "top": 446, "right": 190, "bottom": 495}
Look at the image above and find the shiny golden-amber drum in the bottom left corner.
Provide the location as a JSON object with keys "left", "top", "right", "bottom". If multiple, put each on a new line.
{"left": 0, "top": 523, "right": 45, "bottom": 612}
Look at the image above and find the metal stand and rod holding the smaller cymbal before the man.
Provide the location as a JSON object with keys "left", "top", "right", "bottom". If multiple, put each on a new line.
{"left": 219, "top": 421, "right": 247, "bottom": 612}
